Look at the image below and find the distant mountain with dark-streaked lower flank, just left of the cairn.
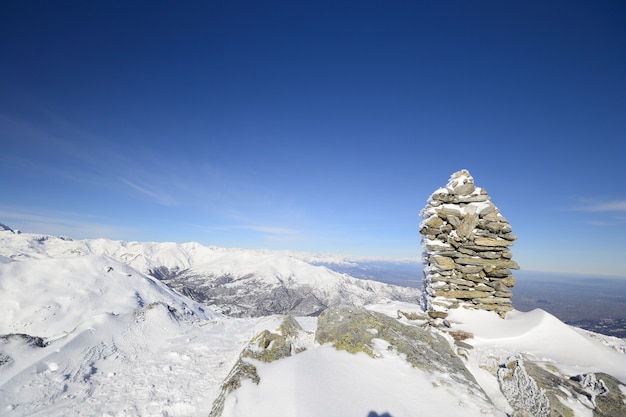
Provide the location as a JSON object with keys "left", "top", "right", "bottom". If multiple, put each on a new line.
{"left": 152, "top": 255, "right": 421, "bottom": 317}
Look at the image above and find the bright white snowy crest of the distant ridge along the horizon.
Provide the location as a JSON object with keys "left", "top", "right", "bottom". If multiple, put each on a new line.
{"left": 0, "top": 231, "right": 418, "bottom": 299}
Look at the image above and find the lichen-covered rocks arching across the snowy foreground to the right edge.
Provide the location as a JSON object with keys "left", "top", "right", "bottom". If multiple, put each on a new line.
{"left": 209, "top": 306, "right": 626, "bottom": 417}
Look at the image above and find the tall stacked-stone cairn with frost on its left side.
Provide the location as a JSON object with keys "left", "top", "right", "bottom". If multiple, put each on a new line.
{"left": 420, "top": 170, "right": 519, "bottom": 318}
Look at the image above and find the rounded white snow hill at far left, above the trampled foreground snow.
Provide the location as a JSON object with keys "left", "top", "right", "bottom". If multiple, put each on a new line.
{"left": 0, "top": 255, "right": 215, "bottom": 338}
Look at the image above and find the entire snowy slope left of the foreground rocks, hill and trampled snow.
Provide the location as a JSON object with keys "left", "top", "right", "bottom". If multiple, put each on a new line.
{"left": 0, "top": 256, "right": 254, "bottom": 416}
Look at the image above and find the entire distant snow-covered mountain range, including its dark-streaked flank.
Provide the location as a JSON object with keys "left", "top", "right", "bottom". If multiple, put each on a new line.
{"left": 0, "top": 231, "right": 421, "bottom": 317}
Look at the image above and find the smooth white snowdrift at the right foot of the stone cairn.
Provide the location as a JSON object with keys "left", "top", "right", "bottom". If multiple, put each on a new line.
{"left": 448, "top": 309, "right": 626, "bottom": 415}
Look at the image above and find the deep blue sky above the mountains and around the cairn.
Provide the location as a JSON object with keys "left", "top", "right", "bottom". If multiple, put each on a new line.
{"left": 0, "top": 1, "right": 626, "bottom": 276}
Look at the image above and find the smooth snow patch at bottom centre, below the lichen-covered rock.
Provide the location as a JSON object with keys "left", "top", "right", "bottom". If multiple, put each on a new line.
{"left": 224, "top": 341, "right": 504, "bottom": 417}
